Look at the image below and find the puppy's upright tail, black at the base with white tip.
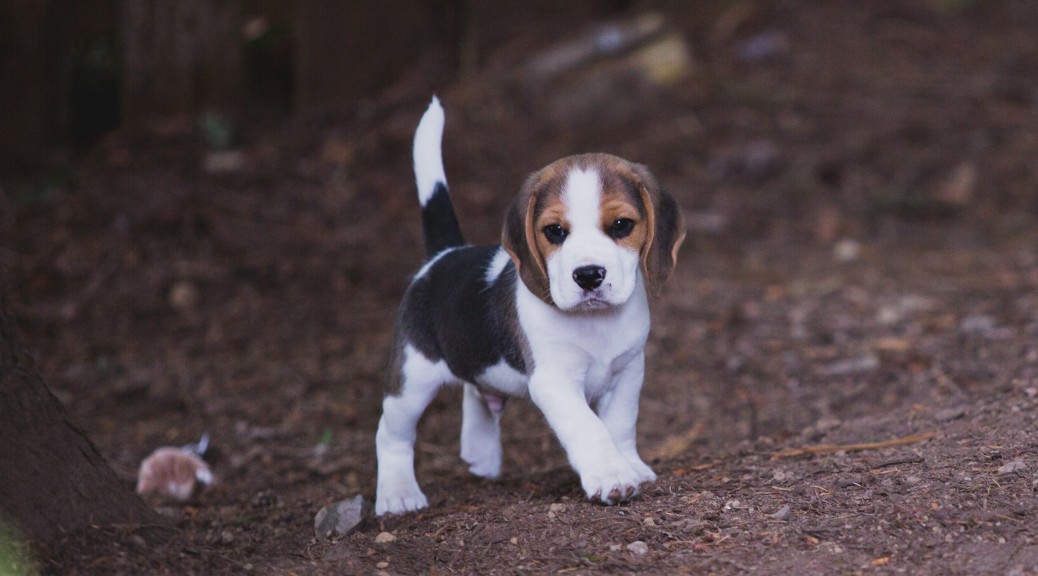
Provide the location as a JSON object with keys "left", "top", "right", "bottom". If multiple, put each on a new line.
{"left": 414, "top": 97, "right": 465, "bottom": 257}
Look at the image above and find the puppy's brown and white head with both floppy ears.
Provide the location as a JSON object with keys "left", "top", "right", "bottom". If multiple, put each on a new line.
{"left": 501, "top": 154, "right": 685, "bottom": 310}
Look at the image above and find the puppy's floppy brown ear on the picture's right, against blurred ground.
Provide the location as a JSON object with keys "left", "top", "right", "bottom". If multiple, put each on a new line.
{"left": 631, "top": 164, "right": 685, "bottom": 296}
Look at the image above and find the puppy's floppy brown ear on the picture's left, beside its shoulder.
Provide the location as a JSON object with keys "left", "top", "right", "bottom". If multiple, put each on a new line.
{"left": 501, "top": 174, "right": 552, "bottom": 304}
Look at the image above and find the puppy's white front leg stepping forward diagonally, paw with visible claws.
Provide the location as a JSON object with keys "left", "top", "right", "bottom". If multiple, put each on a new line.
{"left": 529, "top": 374, "right": 639, "bottom": 504}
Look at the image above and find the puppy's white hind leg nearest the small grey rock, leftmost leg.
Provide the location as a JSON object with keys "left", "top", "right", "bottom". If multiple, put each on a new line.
{"left": 375, "top": 353, "right": 453, "bottom": 516}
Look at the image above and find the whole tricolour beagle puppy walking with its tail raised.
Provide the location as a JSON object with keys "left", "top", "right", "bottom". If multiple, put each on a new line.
{"left": 375, "top": 98, "right": 685, "bottom": 516}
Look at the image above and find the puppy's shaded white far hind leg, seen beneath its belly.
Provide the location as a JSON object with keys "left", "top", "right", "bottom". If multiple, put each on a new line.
{"left": 461, "top": 382, "right": 501, "bottom": 478}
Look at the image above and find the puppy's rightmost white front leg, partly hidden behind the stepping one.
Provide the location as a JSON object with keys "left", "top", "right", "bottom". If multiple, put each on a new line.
{"left": 596, "top": 353, "right": 656, "bottom": 483}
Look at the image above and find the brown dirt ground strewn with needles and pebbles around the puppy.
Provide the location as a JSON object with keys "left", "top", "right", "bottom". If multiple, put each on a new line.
{"left": 0, "top": 0, "right": 1038, "bottom": 575}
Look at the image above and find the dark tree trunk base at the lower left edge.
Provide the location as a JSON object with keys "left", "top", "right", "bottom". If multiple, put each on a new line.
{"left": 0, "top": 306, "right": 165, "bottom": 542}
